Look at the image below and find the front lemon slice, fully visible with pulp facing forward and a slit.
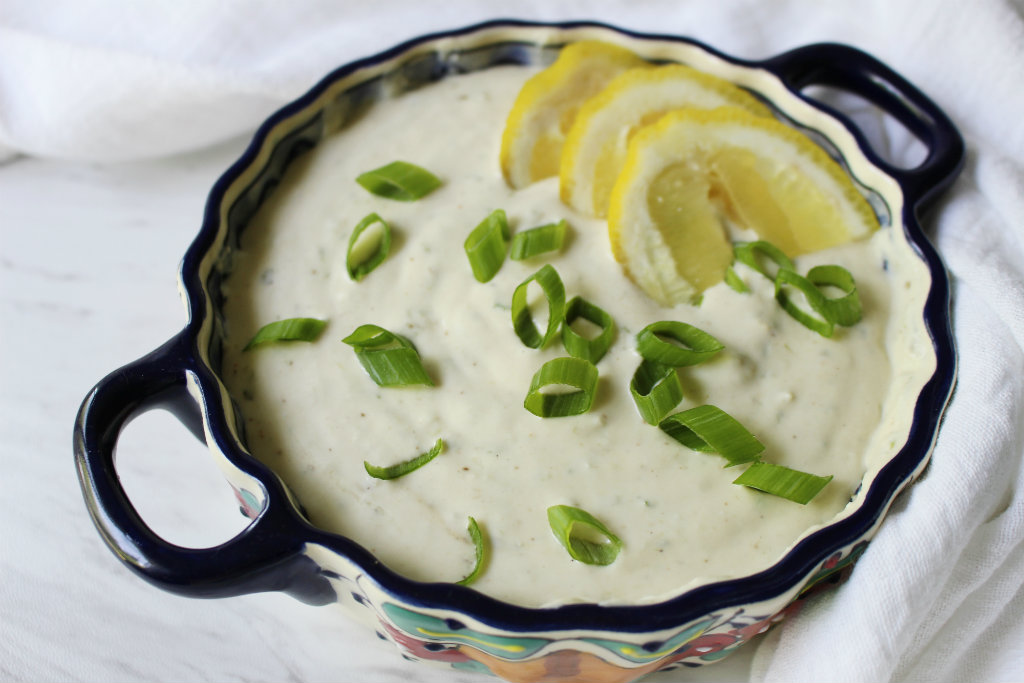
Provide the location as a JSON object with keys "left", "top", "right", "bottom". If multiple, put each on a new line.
{"left": 608, "top": 108, "right": 879, "bottom": 305}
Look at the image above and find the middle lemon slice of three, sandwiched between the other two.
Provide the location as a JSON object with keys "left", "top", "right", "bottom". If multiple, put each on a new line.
{"left": 559, "top": 65, "right": 771, "bottom": 218}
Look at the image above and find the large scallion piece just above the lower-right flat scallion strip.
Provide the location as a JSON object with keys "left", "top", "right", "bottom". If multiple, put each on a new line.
{"left": 658, "top": 405, "right": 765, "bottom": 467}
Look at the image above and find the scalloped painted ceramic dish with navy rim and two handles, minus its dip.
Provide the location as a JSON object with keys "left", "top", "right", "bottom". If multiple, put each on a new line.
{"left": 74, "top": 22, "right": 964, "bottom": 682}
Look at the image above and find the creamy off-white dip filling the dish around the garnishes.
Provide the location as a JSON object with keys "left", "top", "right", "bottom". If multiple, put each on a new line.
{"left": 222, "top": 67, "right": 925, "bottom": 606}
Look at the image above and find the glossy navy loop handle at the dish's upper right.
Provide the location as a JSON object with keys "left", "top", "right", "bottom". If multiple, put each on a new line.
{"left": 763, "top": 43, "right": 964, "bottom": 209}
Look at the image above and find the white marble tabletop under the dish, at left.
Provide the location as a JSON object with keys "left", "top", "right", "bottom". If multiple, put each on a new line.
{"left": 0, "top": 139, "right": 755, "bottom": 683}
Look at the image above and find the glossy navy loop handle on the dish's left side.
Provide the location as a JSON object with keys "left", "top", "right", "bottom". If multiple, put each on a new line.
{"left": 74, "top": 333, "right": 335, "bottom": 604}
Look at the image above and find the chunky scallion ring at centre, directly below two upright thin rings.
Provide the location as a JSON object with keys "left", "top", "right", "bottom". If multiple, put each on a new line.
{"left": 523, "top": 357, "right": 598, "bottom": 418}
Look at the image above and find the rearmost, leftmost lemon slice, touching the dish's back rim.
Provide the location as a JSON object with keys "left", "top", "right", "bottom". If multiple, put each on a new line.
{"left": 501, "top": 41, "right": 646, "bottom": 187}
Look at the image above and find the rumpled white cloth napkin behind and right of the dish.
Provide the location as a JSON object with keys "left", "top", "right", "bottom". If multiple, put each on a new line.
{"left": 0, "top": 0, "right": 1024, "bottom": 681}
